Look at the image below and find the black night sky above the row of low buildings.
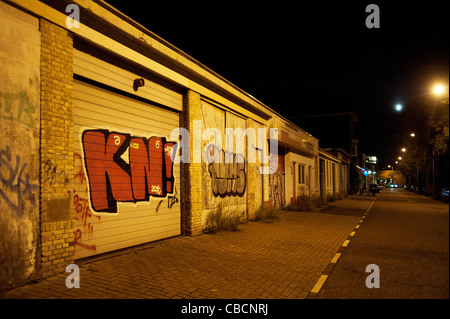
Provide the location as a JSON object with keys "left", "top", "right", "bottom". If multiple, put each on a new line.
{"left": 107, "top": 0, "right": 450, "bottom": 168}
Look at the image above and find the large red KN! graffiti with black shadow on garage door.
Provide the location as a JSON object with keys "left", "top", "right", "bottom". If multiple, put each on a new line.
{"left": 82, "top": 130, "right": 176, "bottom": 213}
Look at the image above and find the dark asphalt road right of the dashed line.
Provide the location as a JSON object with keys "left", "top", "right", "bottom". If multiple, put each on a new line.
{"left": 316, "top": 189, "right": 449, "bottom": 299}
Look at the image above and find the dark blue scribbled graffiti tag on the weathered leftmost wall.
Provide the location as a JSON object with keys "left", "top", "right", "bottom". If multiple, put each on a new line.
{"left": 0, "top": 145, "right": 39, "bottom": 216}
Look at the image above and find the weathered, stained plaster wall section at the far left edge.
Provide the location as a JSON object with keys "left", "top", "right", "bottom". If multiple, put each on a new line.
{"left": 0, "top": 2, "right": 41, "bottom": 288}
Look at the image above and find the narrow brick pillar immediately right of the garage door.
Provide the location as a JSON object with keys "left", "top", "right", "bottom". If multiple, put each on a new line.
{"left": 181, "top": 90, "right": 202, "bottom": 236}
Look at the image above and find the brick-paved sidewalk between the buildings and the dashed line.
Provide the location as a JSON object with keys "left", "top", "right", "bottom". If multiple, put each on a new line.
{"left": 0, "top": 198, "right": 375, "bottom": 299}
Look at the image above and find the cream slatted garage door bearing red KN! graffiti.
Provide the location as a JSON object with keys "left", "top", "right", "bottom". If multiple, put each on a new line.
{"left": 73, "top": 80, "right": 181, "bottom": 259}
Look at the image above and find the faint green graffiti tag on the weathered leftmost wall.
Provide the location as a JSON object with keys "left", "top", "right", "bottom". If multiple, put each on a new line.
{"left": 0, "top": 91, "right": 36, "bottom": 128}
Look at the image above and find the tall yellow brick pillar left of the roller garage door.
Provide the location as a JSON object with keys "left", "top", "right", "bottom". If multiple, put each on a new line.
{"left": 40, "top": 19, "right": 74, "bottom": 278}
